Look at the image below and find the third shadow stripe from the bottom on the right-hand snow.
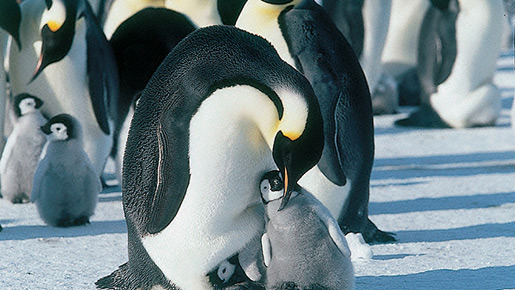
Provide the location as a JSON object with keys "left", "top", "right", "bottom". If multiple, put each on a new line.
{"left": 368, "top": 192, "right": 515, "bottom": 214}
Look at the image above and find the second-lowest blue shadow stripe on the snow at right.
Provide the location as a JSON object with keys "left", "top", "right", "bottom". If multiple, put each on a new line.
{"left": 395, "top": 222, "right": 515, "bottom": 244}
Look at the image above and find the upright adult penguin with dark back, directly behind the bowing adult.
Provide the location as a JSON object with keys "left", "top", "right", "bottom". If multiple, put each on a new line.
{"left": 236, "top": 0, "right": 395, "bottom": 242}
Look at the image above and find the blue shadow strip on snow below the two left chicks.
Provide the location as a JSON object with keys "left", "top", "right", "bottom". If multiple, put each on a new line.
{"left": 0, "top": 220, "right": 127, "bottom": 241}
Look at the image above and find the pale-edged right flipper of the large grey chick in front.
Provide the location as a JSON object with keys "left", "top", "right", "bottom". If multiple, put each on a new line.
{"left": 304, "top": 193, "right": 350, "bottom": 257}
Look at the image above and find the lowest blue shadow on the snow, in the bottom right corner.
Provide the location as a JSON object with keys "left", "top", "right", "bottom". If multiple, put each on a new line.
{"left": 355, "top": 266, "right": 515, "bottom": 290}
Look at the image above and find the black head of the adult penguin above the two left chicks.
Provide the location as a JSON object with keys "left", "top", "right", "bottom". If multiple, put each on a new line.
{"left": 31, "top": 0, "right": 79, "bottom": 81}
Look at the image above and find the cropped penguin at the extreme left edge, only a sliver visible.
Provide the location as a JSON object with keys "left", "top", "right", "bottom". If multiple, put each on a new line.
{"left": 0, "top": 0, "right": 21, "bottom": 150}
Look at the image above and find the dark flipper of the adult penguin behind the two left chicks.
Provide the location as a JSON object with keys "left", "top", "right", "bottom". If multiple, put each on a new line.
{"left": 81, "top": 1, "right": 119, "bottom": 134}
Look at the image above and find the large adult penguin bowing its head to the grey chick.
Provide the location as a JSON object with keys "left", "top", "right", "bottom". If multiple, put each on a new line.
{"left": 96, "top": 25, "right": 323, "bottom": 289}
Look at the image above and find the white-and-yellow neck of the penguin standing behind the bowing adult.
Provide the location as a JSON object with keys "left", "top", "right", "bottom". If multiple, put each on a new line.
{"left": 236, "top": 0, "right": 300, "bottom": 67}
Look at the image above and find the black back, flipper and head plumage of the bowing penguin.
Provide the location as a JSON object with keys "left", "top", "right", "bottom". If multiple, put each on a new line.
{"left": 122, "top": 26, "right": 323, "bottom": 235}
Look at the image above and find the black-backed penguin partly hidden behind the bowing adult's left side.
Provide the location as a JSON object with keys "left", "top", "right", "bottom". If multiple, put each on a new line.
{"left": 109, "top": 8, "right": 196, "bottom": 180}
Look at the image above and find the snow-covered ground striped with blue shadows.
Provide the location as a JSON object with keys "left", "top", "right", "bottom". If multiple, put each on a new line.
{"left": 0, "top": 52, "right": 515, "bottom": 289}
